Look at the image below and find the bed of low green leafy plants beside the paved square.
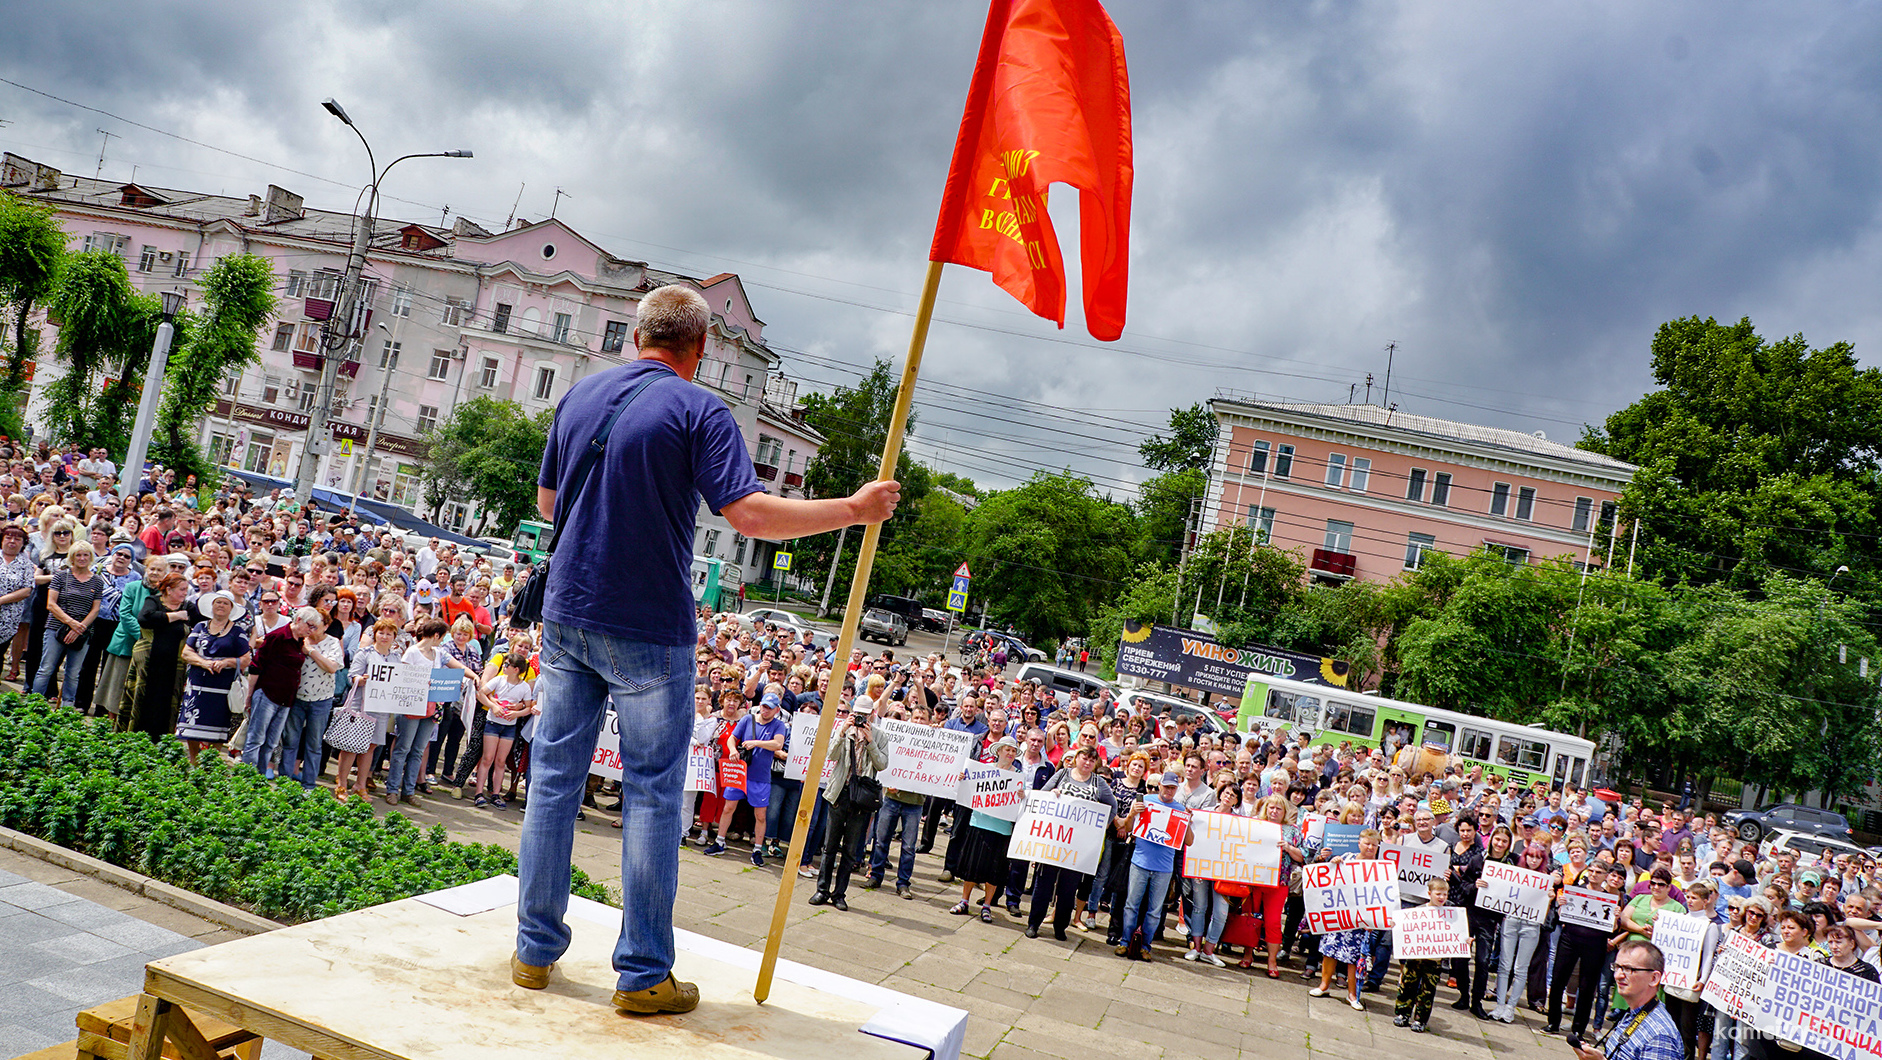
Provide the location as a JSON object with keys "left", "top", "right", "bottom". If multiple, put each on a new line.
{"left": 0, "top": 693, "right": 608, "bottom": 921}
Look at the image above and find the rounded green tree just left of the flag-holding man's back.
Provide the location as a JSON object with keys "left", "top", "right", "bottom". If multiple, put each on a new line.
{"left": 422, "top": 395, "right": 555, "bottom": 535}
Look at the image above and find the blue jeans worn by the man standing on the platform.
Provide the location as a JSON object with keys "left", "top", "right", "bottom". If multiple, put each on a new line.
{"left": 516, "top": 621, "right": 693, "bottom": 990}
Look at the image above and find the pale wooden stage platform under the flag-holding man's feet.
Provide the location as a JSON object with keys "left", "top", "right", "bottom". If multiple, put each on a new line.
{"left": 128, "top": 877, "right": 965, "bottom": 1060}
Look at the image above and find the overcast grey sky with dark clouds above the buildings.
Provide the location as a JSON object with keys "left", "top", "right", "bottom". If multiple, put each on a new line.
{"left": 0, "top": 0, "right": 1882, "bottom": 497}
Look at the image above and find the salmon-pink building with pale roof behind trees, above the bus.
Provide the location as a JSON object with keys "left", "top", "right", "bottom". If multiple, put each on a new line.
{"left": 1203, "top": 397, "right": 1634, "bottom": 582}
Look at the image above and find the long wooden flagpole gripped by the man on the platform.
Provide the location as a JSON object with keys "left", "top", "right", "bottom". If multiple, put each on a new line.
{"left": 751, "top": 262, "right": 941, "bottom": 1005}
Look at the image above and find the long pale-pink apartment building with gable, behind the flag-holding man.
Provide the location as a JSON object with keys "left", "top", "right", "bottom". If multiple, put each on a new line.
{"left": 0, "top": 154, "right": 822, "bottom": 586}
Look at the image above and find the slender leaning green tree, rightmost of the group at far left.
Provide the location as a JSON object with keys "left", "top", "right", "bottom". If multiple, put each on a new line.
{"left": 151, "top": 254, "right": 277, "bottom": 484}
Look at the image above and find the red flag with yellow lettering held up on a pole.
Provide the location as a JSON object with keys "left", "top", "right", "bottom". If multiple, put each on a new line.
{"left": 928, "top": 0, "right": 1131, "bottom": 341}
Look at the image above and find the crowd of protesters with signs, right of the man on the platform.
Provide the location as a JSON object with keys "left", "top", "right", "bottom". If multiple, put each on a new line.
{"left": 683, "top": 612, "right": 1882, "bottom": 1060}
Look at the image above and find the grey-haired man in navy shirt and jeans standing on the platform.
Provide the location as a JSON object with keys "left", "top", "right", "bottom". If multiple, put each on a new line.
{"left": 510, "top": 284, "right": 901, "bottom": 1015}
